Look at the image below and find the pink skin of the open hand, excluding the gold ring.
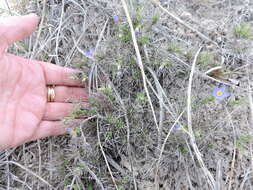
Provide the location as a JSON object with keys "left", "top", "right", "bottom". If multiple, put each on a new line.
{"left": 0, "top": 14, "right": 88, "bottom": 150}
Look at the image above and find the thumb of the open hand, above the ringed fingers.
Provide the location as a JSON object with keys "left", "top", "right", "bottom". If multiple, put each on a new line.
{"left": 0, "top": 14, "right": 39, "bottom": 50}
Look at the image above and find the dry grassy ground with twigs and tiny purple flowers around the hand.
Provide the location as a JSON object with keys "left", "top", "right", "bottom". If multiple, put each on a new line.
{"left": 0, "top": 0, "right": 253, "bottom": 190}
